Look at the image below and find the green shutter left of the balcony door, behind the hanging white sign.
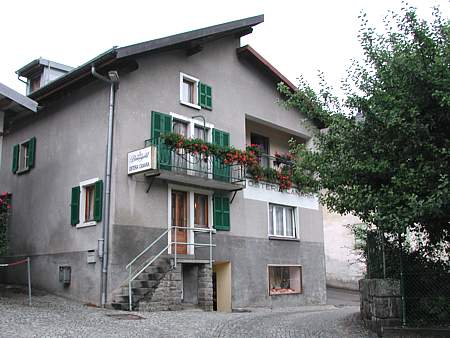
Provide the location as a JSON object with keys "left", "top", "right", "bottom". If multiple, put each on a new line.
{"left": 151, "top": 111, "right": 172, "bottom": 170}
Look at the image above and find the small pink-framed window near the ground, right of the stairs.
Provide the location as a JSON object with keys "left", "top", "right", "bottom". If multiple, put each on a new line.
{"left": 268, "top": 265, "right": 302, "bottom": 296}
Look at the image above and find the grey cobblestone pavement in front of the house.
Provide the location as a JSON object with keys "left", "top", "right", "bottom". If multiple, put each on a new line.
{"left": 0, "top": 288, "right": 374, "bottom": 338}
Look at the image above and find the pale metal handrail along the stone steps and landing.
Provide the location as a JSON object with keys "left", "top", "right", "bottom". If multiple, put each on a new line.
{"left": 126, "top": 225, "right": 216, "bottom": 311}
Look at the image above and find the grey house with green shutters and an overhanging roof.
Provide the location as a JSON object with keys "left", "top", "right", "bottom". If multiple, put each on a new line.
{"left": 0, "top": 16, "right": 326, "bottom": 311}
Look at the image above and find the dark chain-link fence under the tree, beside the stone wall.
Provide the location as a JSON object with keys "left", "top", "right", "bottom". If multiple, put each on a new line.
{"left": 365, "top": 231, "right": 450, "bottom": 327}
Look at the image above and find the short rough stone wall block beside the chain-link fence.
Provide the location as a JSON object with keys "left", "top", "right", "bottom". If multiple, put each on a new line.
{"left": 359, "top": 279, "right": 401, "bottom": 334}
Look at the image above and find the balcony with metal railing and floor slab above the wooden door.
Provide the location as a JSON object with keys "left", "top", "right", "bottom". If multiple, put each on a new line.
{"left": 145, "top": 138, "right": 246, "bottom": 191}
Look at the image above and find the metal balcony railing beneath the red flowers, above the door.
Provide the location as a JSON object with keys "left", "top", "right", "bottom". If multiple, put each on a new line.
{"left": 145, "top": 138, "right": 245, "bottom": 185}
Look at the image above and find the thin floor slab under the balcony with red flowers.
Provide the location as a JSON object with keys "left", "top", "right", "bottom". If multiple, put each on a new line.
{"left": 145, "top": 169, "right": 246, "bottom": 191}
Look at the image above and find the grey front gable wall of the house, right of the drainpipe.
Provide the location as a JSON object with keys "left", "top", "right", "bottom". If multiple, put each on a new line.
{"left": 110, "top": 38, "right": 325, "bottom": 307}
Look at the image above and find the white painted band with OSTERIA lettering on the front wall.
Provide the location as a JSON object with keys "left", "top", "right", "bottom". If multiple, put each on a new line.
{"left": 244, "top": 180, "right": 319, "bottom": 210}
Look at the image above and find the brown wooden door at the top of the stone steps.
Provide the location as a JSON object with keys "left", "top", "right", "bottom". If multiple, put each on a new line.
{"left": 172, "top": 190, "right": 188, "bottom": 255}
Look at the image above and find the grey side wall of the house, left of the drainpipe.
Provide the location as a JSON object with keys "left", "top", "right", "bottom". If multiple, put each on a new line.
{"left": 0, "top": 84, "right": 109, "bottom": 303}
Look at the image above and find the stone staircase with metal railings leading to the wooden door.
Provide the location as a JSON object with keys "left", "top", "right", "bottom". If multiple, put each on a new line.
{"left": 111, "top": 226, "right": 216, "bottom": 311}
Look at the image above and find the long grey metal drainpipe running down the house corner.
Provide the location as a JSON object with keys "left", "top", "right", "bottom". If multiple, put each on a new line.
{"left": 91, "top": 65, "right": 119, "bottom": 307}
